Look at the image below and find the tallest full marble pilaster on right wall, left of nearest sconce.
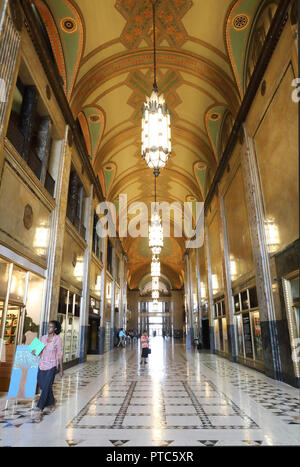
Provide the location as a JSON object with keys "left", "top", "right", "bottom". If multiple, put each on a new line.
{"left": 241, "top": 124, "right": 282, "bottom": 380}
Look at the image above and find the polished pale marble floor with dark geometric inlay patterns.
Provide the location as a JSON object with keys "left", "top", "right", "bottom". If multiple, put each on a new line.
{"left": 0, "top": 337, "right": 300, "bottom": 447}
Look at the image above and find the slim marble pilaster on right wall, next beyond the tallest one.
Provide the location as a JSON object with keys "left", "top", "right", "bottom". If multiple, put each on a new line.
{"left": 219, "top": 188, "right": 237, "bottom": 362}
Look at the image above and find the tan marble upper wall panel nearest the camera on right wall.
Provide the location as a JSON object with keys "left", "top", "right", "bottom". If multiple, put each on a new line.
{"left": 254, "top": 64, "right": 299, "bottom": 254}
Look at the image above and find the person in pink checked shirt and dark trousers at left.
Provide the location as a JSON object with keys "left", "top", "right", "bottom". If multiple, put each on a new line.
{"left": 32, "top": 321, "right": 63, "bottom": 422}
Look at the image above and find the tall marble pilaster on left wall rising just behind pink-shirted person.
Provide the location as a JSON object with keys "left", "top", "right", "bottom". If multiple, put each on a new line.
{"left": 43, "top": 127, "right": 71, "bottom": 326}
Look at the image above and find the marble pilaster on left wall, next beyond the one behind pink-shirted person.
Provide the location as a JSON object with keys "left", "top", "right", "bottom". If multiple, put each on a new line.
{"left": 79, "top": 185, "right": 94, "bottom": 362}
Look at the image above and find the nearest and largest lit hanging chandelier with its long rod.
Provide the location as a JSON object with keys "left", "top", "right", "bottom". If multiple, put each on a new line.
{"left": 142, "top": 0, "right": 171, "bottom": 177}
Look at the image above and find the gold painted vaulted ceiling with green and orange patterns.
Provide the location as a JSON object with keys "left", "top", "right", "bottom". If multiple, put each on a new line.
{"left": 34, "top": 0, "right": 276, "bottom": 288}
